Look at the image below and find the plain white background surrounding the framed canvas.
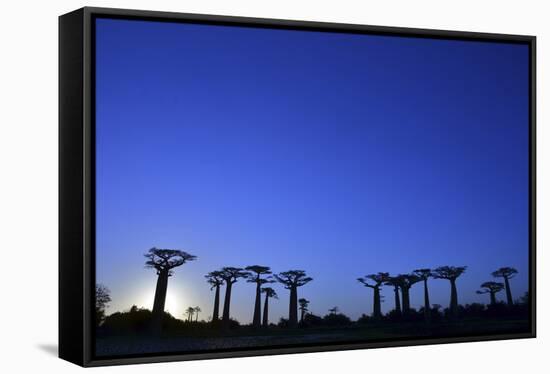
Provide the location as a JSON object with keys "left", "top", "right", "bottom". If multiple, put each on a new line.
{"left": 0, "top": 0, "right": 550, "bottom": 374}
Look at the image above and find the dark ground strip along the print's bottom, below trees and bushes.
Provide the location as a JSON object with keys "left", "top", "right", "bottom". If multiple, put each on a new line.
{"left": 96, "top": 319, "right": 529, "bottom": 356}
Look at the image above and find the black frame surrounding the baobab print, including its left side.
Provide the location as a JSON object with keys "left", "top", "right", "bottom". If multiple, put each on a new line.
{"left": 59, "top": 7, "right": 536, "bottom": 366}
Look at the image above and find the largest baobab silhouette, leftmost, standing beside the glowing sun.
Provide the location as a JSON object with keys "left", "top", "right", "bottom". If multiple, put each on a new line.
{"left": 145, "top": 247, "right": 197, "bottom": 333}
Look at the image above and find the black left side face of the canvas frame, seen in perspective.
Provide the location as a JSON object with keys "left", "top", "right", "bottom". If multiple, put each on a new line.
{"left": 58, "top": 9, "right": 85, "bottom": 366}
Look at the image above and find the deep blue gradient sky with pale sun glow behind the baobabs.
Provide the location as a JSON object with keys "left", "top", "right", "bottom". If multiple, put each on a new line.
{"left": 96, "top": 19, "right": 528, "bottom": 322}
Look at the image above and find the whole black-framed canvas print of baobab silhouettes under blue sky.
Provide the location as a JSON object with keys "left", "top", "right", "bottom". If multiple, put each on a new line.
{"left": 59, "top": 8, "right": 536, "bottom": 366}
